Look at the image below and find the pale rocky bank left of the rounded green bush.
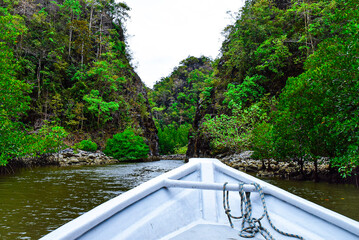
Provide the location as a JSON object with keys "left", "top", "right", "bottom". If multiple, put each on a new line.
{"left": 48, "top": 148, "right": 118, "bottom": 166}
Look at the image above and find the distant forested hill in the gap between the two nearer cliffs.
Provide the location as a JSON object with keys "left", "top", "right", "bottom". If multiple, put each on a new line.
{"left": 149, "top": 56, "right": 213, "bottom": 154}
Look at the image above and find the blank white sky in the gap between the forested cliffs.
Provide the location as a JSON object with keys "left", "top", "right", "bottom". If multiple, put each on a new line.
{"left": 124, "top": 0, "right": 244, "bottom": 88}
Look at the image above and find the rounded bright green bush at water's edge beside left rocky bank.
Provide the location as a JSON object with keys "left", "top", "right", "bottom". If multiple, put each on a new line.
{"left": 104, "top": 129, "right": 149, "bottom": 161}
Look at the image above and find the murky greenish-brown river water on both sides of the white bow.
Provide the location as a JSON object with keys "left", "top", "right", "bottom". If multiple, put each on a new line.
{"left": 0, "top": 160, "right": 359, "bottom": 240}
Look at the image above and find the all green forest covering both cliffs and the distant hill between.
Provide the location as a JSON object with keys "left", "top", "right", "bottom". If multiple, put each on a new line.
{"left": 0, "top": 0, "right": 359, "bottom": 176}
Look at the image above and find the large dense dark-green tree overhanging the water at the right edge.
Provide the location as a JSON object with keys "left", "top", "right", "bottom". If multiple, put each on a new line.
{"left": 274, "top": 1, "right": 359, "bottom": 176}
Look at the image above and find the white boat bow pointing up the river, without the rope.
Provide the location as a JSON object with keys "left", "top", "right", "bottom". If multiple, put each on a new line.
{"left": 42, "top": 159, "right": 359, "bottom": 240}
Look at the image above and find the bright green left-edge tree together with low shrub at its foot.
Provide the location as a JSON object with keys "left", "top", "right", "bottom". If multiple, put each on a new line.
{"left": 0, "top": 8, "right": 66, "bottom": 165}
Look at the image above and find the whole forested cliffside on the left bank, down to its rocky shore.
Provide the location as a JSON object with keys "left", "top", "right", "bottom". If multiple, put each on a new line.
{"left": 0, "top": 0, "right": 156, "bottom": 165}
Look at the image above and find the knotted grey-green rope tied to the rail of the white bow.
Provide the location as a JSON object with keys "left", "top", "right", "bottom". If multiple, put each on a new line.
{"left": 223, "top": 182, "right": 304, "bottom": 240}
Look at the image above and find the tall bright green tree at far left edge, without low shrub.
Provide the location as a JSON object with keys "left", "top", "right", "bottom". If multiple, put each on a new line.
{"left": 0, "top": 8, "right": 30, "bottom": 165}
